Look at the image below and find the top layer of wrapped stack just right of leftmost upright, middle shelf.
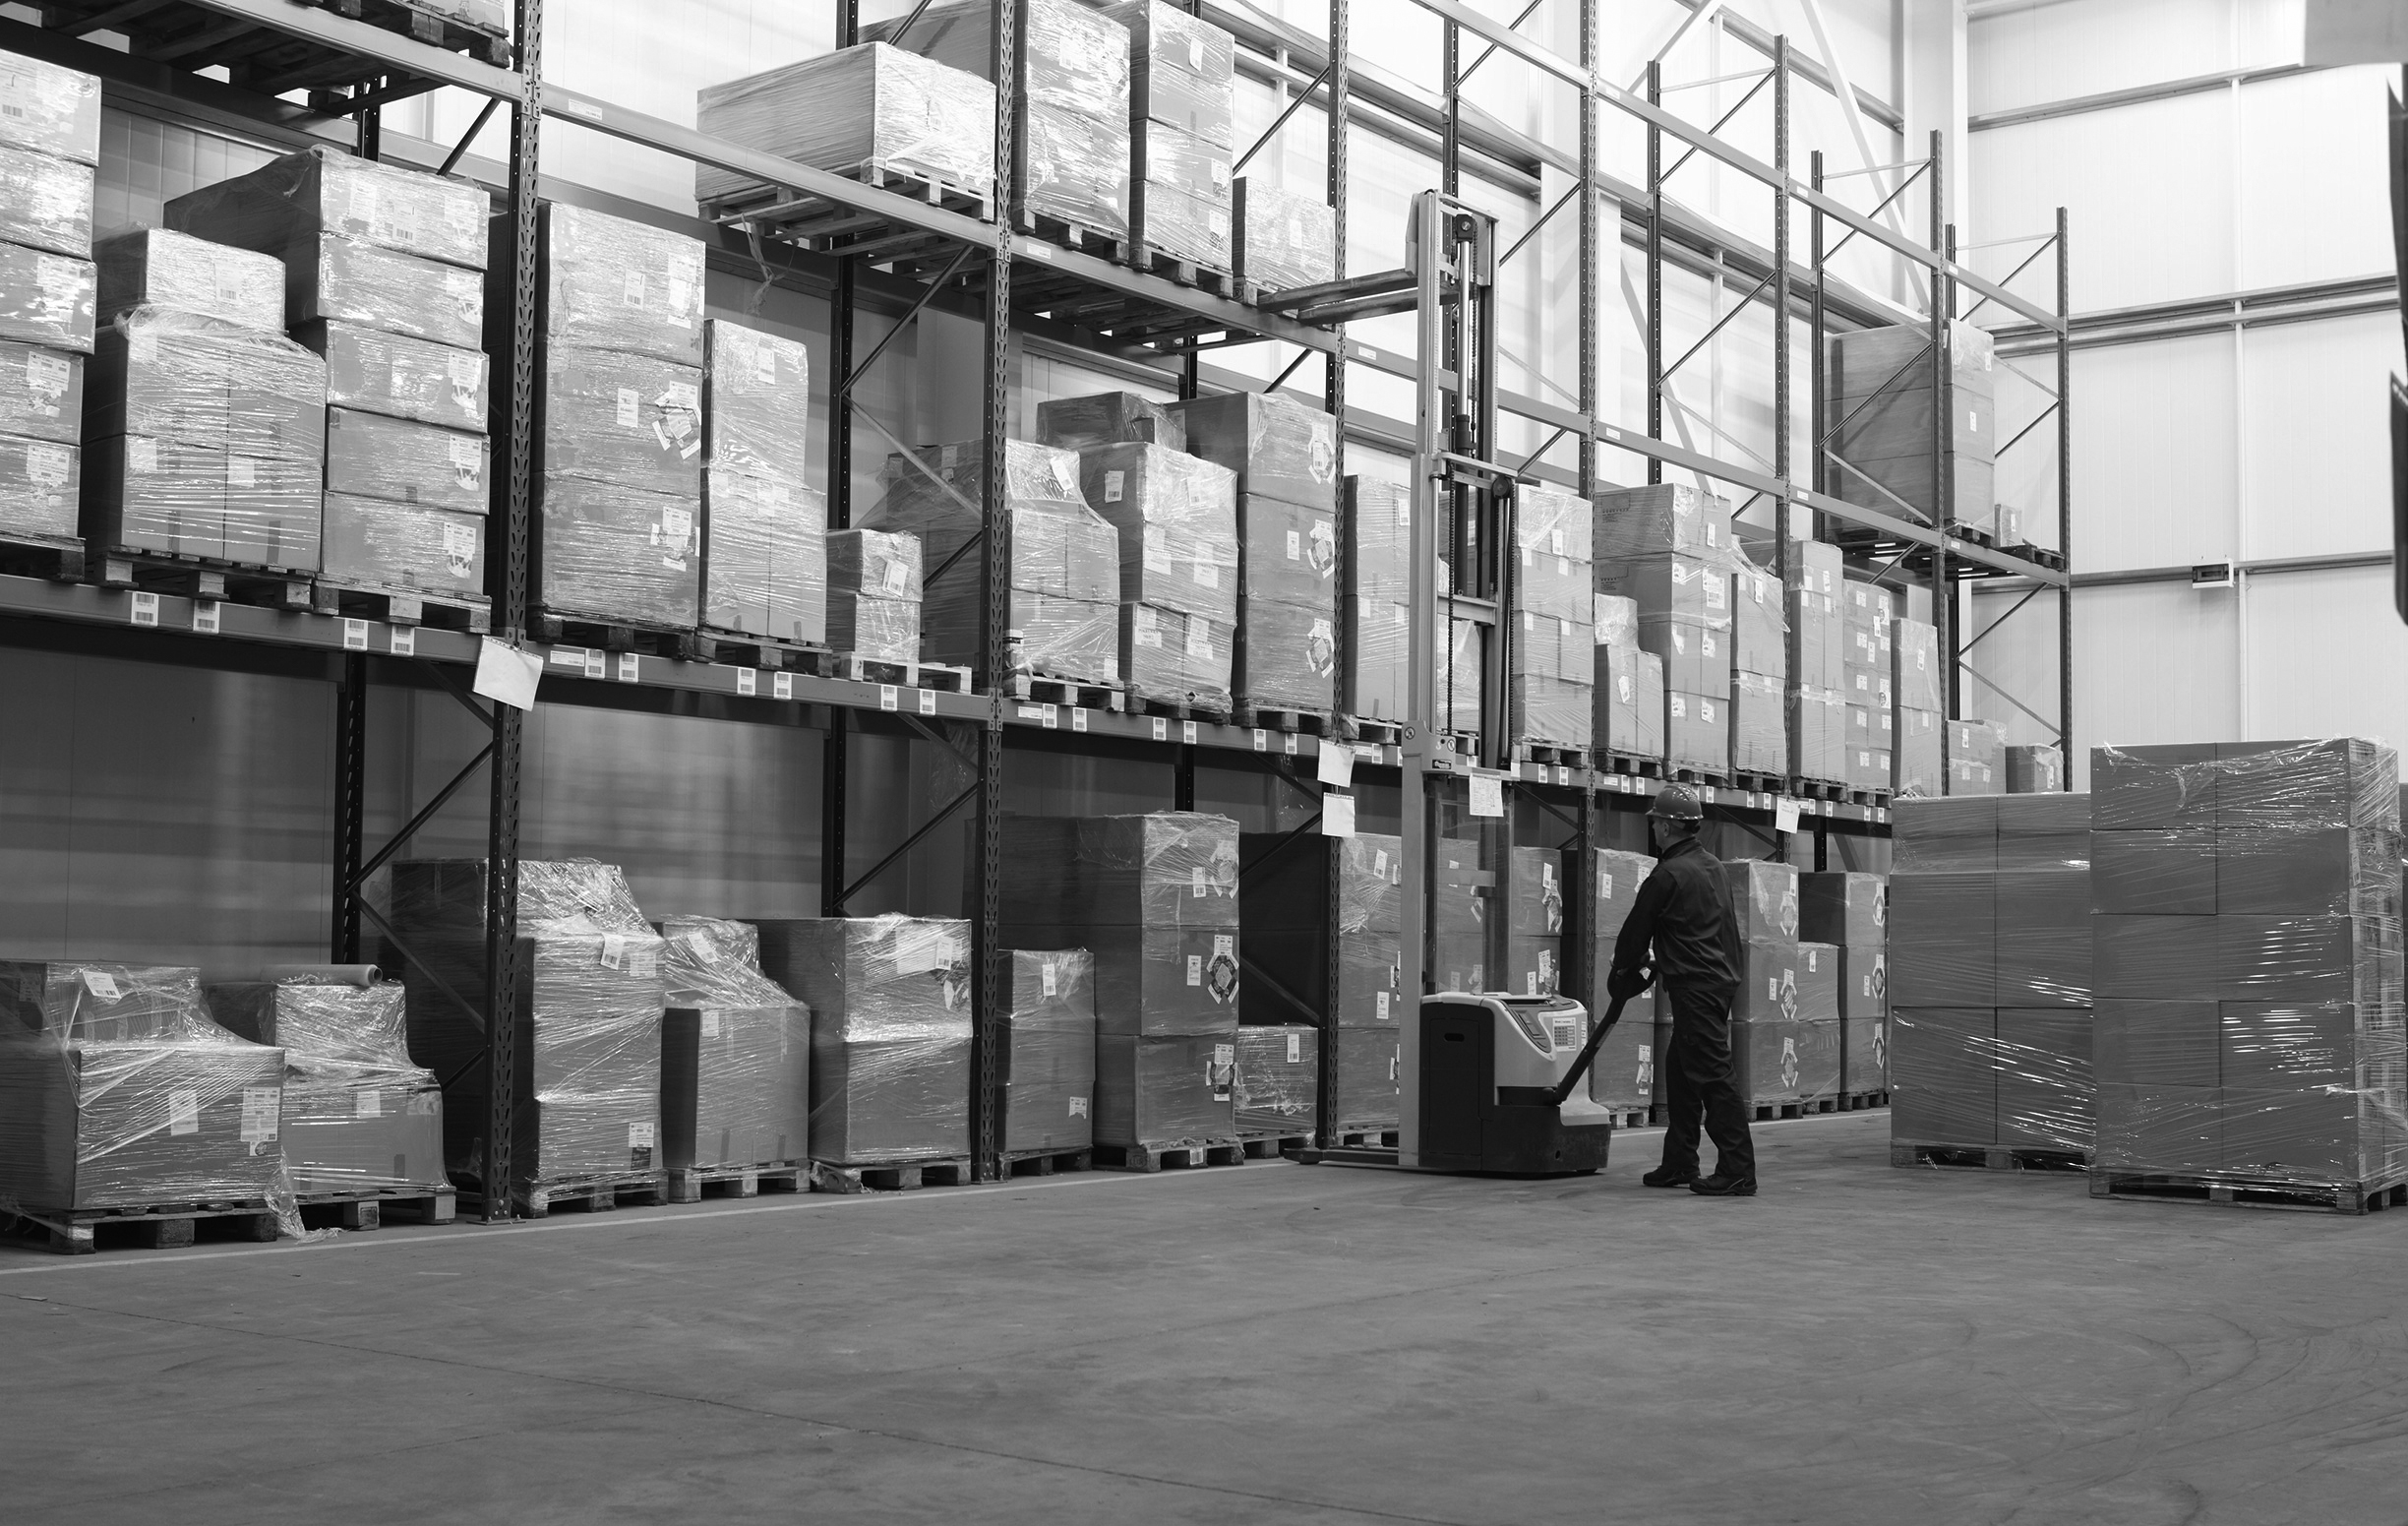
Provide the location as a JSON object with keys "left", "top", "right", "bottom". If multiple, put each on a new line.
{"left": 532, "top": 202, "right": 708, "bottom": 366}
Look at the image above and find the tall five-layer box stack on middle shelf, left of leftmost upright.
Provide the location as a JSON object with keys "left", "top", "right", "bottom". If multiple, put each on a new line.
{"left": 165, "top": 138, "right": 491, "bottom": 631}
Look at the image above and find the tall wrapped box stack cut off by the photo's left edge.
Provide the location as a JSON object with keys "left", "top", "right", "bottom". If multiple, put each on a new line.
{"left": 0, "top": 53, "right": 101, "bottom": 549}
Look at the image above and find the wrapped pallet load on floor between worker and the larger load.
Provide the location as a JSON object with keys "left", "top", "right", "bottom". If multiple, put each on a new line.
{"left": 1891, "top": 794, "right": 2095, "bottom": 1170}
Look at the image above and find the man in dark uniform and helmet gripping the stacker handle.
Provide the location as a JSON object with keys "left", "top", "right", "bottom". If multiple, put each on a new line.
{"left": 1606, "top": 785, "right": 1756, "bottom": 1196}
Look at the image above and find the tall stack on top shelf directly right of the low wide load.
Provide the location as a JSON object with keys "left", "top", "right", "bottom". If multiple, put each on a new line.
{"left": 867, "top": 0, "right": 1129, "bottom": 238}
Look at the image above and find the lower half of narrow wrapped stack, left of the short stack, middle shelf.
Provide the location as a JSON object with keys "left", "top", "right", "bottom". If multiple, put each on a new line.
{"left": 703, "top": 467, "right": 828, "bottom": 645}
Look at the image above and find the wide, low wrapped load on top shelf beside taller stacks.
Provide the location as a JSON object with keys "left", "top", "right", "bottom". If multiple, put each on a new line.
{"left": 693, "top": 40, "right": 996, "bottom": 202}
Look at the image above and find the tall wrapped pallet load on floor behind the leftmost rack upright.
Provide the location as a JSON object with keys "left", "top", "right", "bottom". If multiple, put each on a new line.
{"left": 383, "top": 859, "right": 667, "bottom": 1218}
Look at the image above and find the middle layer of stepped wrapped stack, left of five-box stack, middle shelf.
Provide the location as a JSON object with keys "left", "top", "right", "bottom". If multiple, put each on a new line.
{"left": 85, "top": 308, "right": 325, "bottom": 462}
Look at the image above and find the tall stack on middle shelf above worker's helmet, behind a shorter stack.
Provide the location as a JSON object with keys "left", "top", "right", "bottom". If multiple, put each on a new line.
{"left": 1595, "top": 484, "right": 1731, "bottom": 775}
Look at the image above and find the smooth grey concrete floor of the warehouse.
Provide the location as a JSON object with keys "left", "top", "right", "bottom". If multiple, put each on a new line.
{"left": 0, "top": 1115, "right": 2408, "bottom": 1526}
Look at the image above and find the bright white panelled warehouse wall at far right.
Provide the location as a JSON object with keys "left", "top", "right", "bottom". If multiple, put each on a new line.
{"left": 1965, "top": 0, "right": 2408, "bottom": 782}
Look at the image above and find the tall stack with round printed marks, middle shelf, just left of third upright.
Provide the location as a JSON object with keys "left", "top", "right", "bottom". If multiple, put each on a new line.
{"left": 1177, "top": 393, "right": 1339, "bottom": 715}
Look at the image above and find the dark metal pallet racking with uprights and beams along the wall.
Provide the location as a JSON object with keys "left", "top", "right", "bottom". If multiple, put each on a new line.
{"left": 0, "top": 0, "right": 2071, "bottom": 1213}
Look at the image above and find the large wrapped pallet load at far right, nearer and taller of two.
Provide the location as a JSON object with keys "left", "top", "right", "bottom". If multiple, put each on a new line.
{"left": 2089, "top": 739, "right": 2408, "bottom": 1213}
